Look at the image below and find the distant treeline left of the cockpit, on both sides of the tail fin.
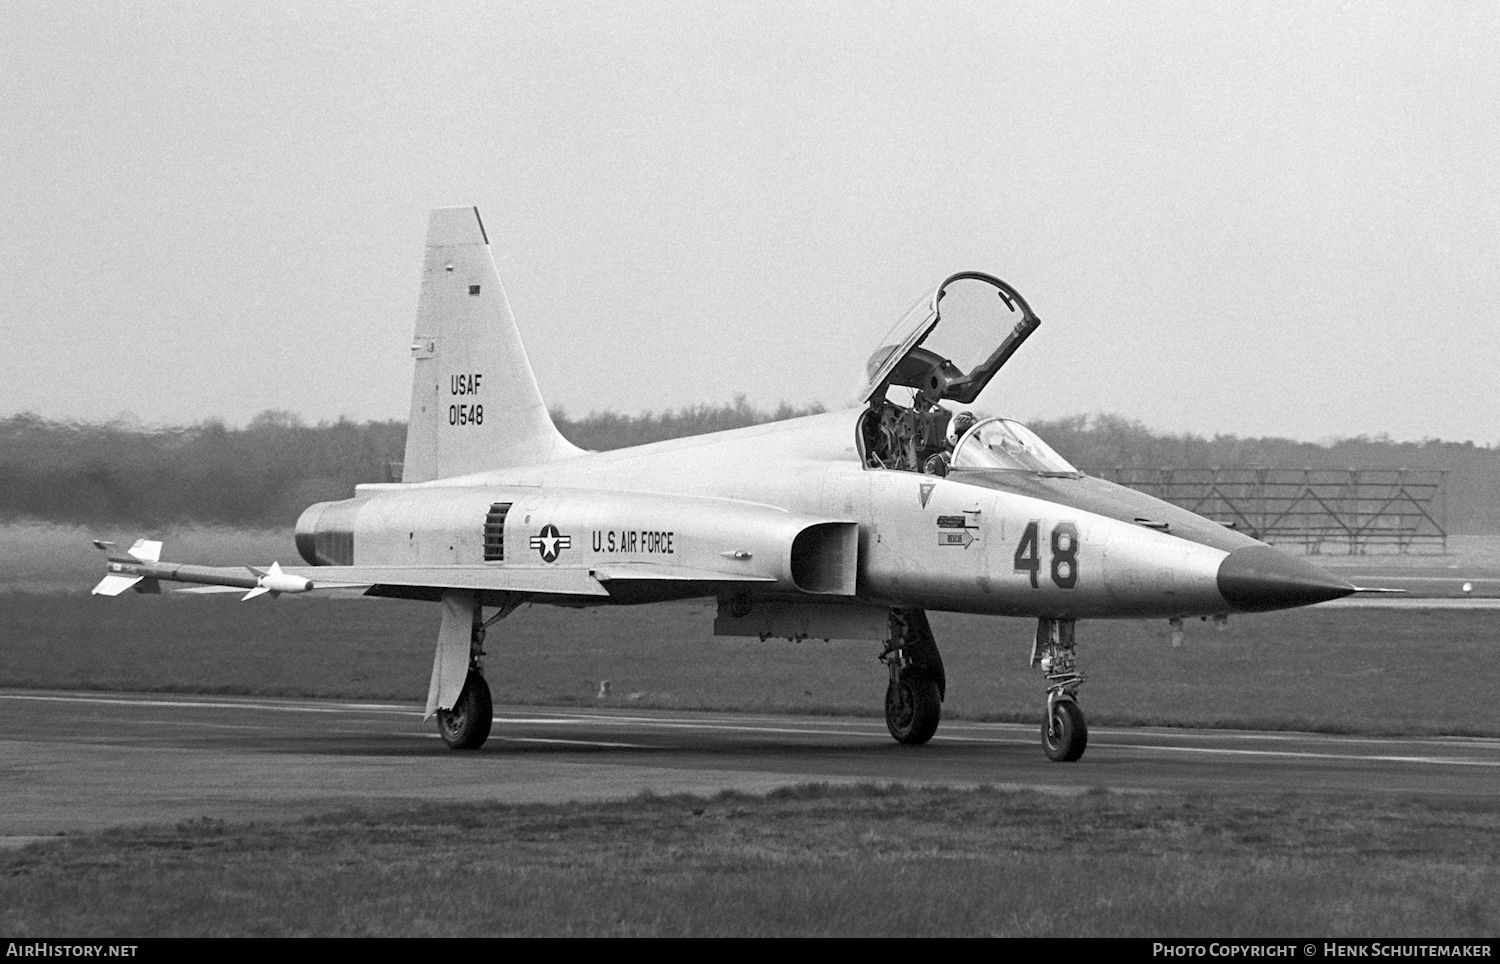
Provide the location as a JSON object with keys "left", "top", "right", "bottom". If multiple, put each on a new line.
{"left": 0, "top": 397, "right": 824, "bottom": 526}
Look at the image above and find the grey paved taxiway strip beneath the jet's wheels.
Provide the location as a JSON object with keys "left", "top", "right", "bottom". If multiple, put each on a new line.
{"left": 0, "top": 690, "right": 1500, "bottom": 844}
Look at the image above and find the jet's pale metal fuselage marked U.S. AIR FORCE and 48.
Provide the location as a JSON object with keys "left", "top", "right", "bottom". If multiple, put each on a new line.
{"left": 299, "top": 411, "right": 1350, "bottom": 619}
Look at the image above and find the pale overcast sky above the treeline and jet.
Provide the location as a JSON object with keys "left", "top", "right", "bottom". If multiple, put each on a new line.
{"left": 0, "top": 0, "right": 1500, "bottom": 444}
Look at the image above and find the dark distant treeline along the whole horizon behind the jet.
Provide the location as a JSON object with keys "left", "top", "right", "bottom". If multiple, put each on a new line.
{"left": 0, "top": 397, "right": 1500, "bottom": 534}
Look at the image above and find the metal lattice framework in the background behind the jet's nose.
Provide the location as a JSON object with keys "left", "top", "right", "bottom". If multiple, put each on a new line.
{"left": 1089, "top": 466, "right": 1448, "bottom": 555}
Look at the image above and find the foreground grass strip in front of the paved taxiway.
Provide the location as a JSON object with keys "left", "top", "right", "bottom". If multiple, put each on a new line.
{"left": 0, "top": 786, "right": 1500, "bottom": 940}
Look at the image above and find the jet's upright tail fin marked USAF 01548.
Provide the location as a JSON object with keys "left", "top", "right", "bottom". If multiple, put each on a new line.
{"left": 402, "top": 207, "right": 582, "bottom": 483}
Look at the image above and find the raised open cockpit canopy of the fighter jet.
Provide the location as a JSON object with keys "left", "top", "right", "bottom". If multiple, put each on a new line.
{"left": 858, "top": 271, "right": 1041, "bottom": 405}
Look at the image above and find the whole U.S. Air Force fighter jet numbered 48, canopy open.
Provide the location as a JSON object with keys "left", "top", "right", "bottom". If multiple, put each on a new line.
{"left": 95, "top": 207, "right": 1358, "bottom": 762}
